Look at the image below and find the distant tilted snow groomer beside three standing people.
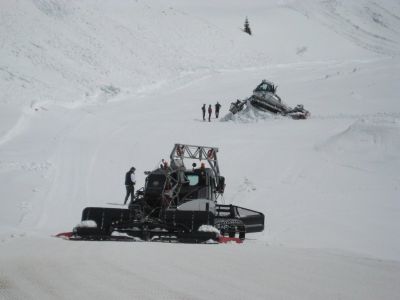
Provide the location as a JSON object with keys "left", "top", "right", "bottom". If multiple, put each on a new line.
{"left": 229, "top": 80, "right": 310, "bottom": 120}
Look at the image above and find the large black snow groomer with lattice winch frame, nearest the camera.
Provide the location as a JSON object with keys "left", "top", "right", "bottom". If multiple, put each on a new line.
{"left": 70, "top": 144, "right": 264, "bottom": 243}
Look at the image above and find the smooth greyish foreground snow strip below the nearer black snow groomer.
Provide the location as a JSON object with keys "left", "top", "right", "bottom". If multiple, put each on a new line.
{"left": 0, "top": 237, "right": 400, "bottom": 299}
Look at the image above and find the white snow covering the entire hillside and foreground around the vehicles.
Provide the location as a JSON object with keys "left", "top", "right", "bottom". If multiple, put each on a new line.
{"left": 0, "top": 0, "right": 400, "bottom": 299}
